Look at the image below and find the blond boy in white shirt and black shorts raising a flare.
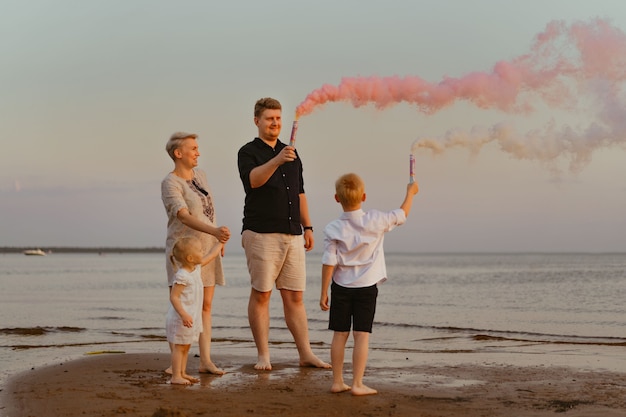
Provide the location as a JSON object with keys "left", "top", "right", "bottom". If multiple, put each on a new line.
{"left": 320, "top": 173, "right": 419, "bottom": 395}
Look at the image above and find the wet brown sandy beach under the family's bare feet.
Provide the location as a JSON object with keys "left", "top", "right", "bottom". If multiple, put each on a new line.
{"left": 0, "top": 353, "right": 626, "bottom": 417}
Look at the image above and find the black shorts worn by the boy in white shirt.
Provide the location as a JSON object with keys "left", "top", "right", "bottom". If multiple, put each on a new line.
{"left": 328, "top": 281, "right": 378, "bottom": 333}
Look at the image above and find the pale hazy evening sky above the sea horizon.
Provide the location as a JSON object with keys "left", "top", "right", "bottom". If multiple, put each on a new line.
{"left": 0, "top": 0, "right": 626, "bottom": 252}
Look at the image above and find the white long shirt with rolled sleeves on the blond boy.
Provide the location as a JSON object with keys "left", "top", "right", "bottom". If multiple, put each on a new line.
{"left": 322, "top": 209, "right": 406, "bottom": 288}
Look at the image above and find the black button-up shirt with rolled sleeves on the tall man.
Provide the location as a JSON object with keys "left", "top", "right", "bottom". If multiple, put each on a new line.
{"left": 237, "top": 138, "right": 304, "bottom": 235}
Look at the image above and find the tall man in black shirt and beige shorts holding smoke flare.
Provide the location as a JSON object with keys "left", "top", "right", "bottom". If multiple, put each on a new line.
{"left": 237, "top": 98, "right": 330, "bottom": 370}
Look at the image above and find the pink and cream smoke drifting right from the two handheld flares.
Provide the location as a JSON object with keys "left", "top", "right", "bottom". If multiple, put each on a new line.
{"left": 296, "top": 19, "right": 626, "bottom": 172}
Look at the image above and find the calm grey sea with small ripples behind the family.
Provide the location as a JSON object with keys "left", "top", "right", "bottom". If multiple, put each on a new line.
{"left": 0, "top": 253, "right": 626, "bottom": 385}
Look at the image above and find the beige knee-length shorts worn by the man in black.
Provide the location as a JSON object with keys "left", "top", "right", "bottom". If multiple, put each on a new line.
{"left": 241, "top": 230, "right": 306, "bottom": 292}
